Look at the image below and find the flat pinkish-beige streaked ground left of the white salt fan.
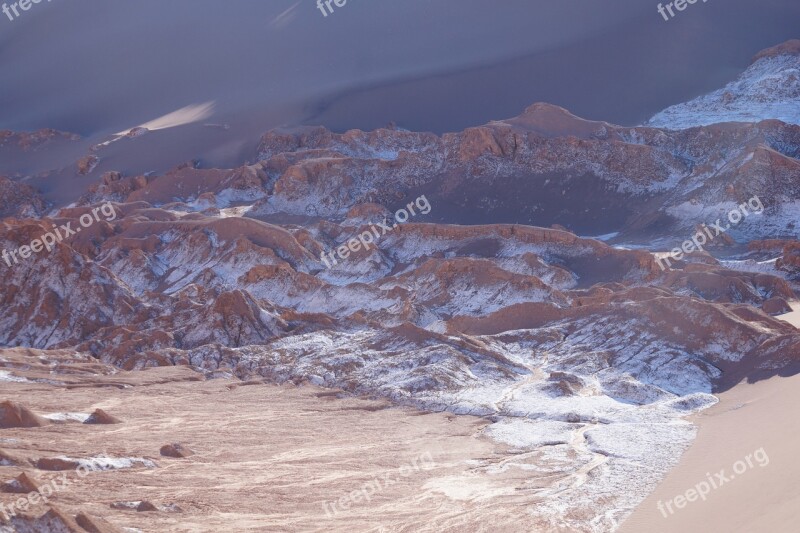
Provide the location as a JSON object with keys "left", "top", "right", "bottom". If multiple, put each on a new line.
{"left": 0, "top": 352, "right": 568, "bottom": 532}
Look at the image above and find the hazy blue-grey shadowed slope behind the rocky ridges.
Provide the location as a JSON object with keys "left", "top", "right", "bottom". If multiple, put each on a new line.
{"left": 0, "top": 0, "right": 800, "bottom": 136}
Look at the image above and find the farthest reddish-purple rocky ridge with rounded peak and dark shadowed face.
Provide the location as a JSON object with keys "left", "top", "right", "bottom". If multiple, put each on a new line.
{"left": 73, "top": 104, "right": 800, "bottom": 241}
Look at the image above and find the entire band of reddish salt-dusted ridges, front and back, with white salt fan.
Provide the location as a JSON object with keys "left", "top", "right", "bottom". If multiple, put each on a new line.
{"left": 0, "top": 40, "right": 800, "bottom": 531}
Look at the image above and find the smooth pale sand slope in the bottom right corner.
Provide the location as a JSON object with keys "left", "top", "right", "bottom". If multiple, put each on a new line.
{"left": 621, "top": 375, "right": 800, "bottom": 533}
